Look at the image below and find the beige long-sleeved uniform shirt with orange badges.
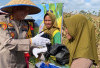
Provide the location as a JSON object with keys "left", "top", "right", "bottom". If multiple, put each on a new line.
{"left": 0, "top": 15, "right": 30, "bottom": 68}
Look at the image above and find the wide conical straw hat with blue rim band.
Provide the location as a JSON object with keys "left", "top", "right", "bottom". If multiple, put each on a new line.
{"left": 1, "top": 0, "right": 41, "bottom": 14}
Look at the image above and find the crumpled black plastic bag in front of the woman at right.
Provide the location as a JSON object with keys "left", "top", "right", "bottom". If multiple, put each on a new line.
{"left": 44, "top": 44, "right": 70, "bottom": 65}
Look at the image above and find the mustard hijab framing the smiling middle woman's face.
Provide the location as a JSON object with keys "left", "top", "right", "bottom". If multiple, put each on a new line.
{"left": 43, "top": 12, "right": 59, "bottom": 35}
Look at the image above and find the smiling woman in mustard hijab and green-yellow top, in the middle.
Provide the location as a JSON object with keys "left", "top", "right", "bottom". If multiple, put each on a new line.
{"left": 43, "top": 11, "right": 61, "bottom": 44}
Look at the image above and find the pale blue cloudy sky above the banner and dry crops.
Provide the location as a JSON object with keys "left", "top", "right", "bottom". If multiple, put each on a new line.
{"left": 0, "top": 0, "right": 100, "bottom": 12}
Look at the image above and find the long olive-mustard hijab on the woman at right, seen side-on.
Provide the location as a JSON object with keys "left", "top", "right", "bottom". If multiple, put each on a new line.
{"left": 64, "top": 14, "right": 98, "bottom": 64}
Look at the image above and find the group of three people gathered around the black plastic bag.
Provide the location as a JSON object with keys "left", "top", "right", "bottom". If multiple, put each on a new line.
{"left": 0, "top": 0, "right": 98, "bottom": 68}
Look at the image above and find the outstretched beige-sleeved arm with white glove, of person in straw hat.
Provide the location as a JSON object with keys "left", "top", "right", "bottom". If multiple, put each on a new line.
{"left": 0, "top": 29, "right": 50, "bottom": 52}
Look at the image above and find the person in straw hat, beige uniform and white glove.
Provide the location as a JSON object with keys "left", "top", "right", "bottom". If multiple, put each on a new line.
{"left": 0, "top": 0, "right": 50, "bottom": 68}
